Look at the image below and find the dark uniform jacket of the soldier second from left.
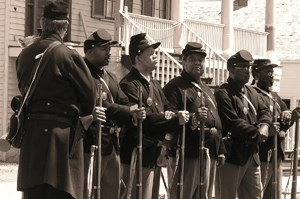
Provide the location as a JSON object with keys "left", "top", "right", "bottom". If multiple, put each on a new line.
{"left": 84, "top": 59, "right": 134, "bottom": 155}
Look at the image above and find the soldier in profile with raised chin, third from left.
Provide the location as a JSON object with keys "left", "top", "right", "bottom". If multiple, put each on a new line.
{"left": 120, "top": 33, "right": 189, "bottom": 199}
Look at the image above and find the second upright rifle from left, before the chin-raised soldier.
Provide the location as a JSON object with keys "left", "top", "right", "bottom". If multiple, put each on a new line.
{"left": 136, "top": 87, "right": 143, "bottom": 199}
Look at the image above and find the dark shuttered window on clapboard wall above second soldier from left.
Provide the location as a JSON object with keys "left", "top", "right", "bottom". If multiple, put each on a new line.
{"left": 92, "top": 0, "right": 116, "bottom": 19}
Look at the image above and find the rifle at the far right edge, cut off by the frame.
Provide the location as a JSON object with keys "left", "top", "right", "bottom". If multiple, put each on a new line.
{"left": 291, "top": 107, "right": 300, "bottom": 199}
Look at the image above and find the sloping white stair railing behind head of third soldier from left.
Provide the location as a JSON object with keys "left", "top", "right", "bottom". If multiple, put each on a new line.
{"left": 120, "top": 9, "right": 182, "bottom": 87}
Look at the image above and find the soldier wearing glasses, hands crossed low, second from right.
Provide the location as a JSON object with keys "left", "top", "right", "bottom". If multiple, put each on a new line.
{"left": 215, "top": 50, "right": 272, "bottom": 199}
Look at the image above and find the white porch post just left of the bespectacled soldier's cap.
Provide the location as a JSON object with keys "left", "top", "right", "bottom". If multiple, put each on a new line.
{"left": 221, "top": 0, "right": 234, "bottom": 58}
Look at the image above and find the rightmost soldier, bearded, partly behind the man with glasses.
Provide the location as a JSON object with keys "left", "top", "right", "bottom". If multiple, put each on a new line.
{"left": 252, "top": 59, "right": 292, "bottom": 199}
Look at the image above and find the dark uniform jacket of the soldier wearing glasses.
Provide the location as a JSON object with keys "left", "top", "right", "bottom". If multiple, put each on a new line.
{"left": 215, "top": 77, "right": 272, "bottom": 166}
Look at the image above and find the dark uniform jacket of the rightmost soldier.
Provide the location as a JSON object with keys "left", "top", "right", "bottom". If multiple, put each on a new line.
{"left": 254, "top": 87, "right": 290, "bottom": 162}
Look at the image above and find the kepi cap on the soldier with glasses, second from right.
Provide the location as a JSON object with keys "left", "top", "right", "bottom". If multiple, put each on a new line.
{"left": 227, "top": 50, "right": 253, "bottom": 69}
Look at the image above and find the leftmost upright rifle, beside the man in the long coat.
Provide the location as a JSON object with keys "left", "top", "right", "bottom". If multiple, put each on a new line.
{"left": 88, "top": 83, "right": 103, "bottom": 199}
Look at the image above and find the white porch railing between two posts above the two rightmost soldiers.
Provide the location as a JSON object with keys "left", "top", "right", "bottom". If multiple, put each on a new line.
{"left": 233, "top": 28, "right": 269, "bottom": 57}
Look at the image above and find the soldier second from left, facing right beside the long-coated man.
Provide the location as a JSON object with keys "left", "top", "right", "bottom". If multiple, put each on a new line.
{"left": 84, "top": 29, "right": 146, "bottom": 199}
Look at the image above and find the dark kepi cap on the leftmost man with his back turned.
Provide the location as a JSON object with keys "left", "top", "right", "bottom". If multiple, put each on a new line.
{"left": 44, "top": 1, "right": 69, "bottom": 20}
